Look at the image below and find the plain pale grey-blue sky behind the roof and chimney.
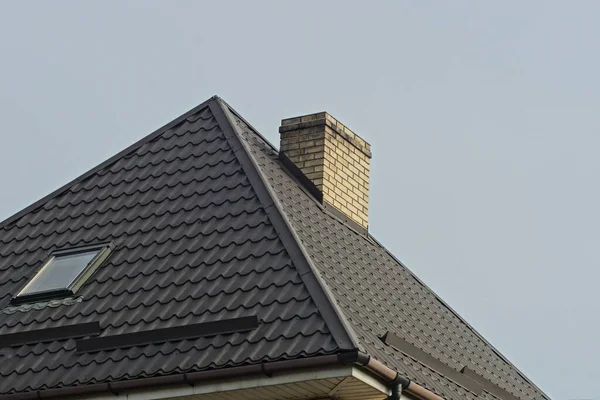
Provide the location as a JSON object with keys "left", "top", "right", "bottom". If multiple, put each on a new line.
{"left": 0, "top": 0, "right": 600, "bottom": 400}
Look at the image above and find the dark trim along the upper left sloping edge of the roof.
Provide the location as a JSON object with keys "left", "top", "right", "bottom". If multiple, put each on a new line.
{"left": 0, "top": 95, "right": 217, "bottom": 229}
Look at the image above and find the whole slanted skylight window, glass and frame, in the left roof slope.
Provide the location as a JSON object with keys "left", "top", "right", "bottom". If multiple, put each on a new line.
{"left": 13, "top": 245, "right": 111, "bottom": 302}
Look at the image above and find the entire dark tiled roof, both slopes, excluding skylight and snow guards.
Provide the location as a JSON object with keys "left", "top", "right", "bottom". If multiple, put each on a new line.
{"left": 0, "top": 98, "right": 546, "bottom": 400}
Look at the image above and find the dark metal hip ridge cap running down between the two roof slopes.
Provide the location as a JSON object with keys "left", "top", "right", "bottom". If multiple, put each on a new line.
{"left": 209, "top": 97, "right": 359, "bottom": 350}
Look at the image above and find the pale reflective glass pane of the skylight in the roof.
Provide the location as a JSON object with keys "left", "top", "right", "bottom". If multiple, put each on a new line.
{"left": 17, "top": 246, "right": 107, "bottom": 297}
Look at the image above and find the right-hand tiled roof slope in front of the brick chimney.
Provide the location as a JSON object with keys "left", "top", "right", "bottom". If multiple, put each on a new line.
{"left": 226, "top": 103, "right": 547, "bottom": 399}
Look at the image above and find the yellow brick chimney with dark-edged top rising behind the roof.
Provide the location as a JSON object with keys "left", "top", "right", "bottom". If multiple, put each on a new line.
{"left": 279, "top": 112, "right": 371, "bottom": 229}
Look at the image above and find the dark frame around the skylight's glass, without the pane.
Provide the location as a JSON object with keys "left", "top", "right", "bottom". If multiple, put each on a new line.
{"left": 11, "top": 243, "right": 114, "bottom": 304}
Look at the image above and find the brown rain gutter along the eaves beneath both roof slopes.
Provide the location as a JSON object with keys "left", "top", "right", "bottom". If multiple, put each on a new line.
{"left": 0, "top": 352, "right": 443, "bottom": 400}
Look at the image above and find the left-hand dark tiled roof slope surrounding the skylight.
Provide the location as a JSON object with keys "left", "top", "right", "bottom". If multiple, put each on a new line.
{"left": 0, "top": 99, "right": 351, "bottom": 394}
